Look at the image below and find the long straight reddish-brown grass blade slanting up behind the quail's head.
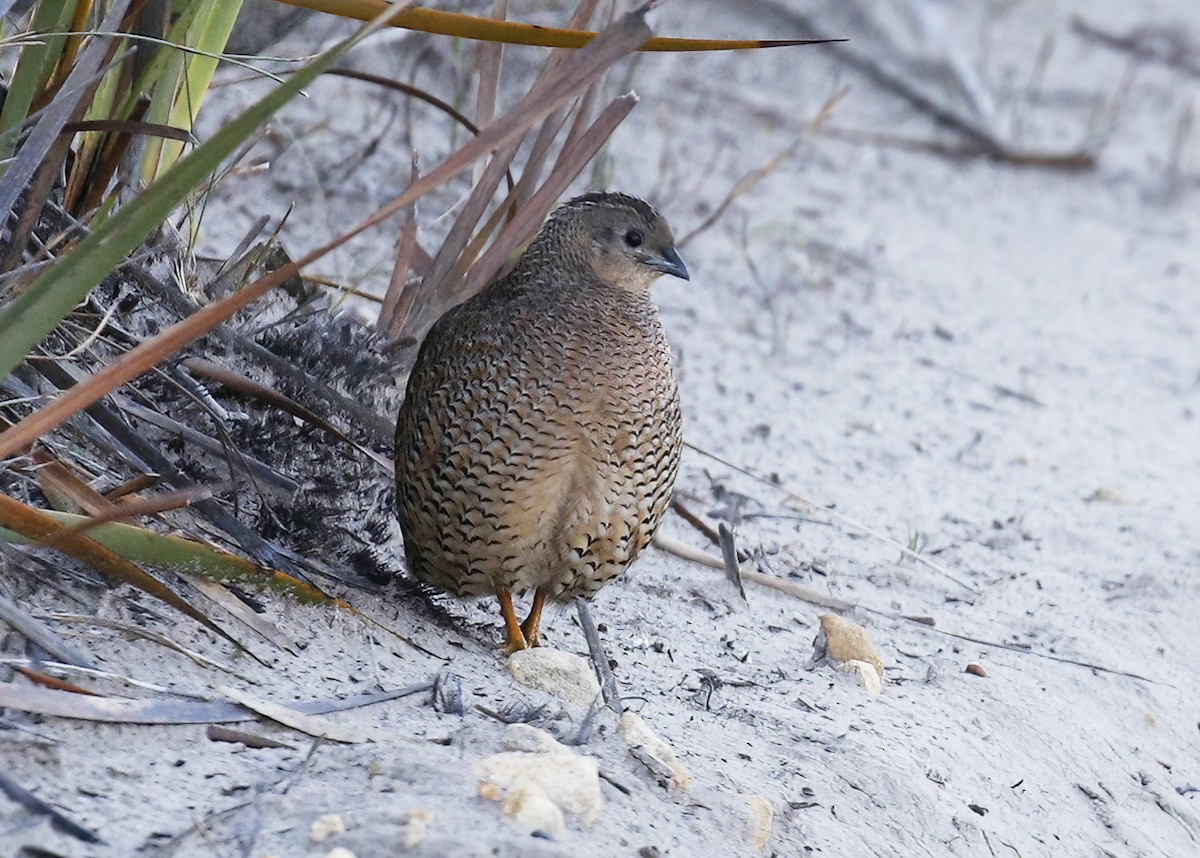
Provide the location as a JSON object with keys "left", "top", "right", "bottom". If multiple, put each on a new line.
{"left": 0, "top": 1, "right": 650, "bottom": 460}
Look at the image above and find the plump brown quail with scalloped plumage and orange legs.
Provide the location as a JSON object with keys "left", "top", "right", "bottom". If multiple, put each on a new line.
{"left": 396, "top": 193, "right": 688, "bottom": 652}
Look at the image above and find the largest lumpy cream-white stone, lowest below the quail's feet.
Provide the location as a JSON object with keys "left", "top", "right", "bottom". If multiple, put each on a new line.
{"left": 476, "top": 744, "right": 604, "bottom": 836}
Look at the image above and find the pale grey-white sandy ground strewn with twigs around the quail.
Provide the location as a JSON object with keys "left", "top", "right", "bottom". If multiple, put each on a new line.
{"left": 0, "top": 0, "right": 1200, "bottom": 858}
